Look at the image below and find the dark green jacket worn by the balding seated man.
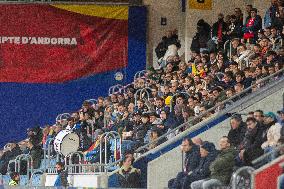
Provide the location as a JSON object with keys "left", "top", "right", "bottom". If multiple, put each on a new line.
{"left": 210, "top": 147, "right": 237, "bottom": 185}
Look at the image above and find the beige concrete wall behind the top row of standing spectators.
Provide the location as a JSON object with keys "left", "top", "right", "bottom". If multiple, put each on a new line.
{"left": 143, "top": 0, "right": 270, "bottom": 65}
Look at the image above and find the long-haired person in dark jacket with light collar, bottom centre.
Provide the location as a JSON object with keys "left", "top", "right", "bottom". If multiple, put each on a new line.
{"left": 116, "top": 155, "right": 141, "bottom": 188}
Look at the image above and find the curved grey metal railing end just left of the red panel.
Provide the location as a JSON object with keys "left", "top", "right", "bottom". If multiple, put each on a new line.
{"left": 232, "top": 166, "right": 255, "bottom": 189}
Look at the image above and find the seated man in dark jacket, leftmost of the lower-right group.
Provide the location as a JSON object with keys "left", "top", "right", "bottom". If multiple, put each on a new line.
{"left": 168, "top": 138, "right": 200, "bottom": 188}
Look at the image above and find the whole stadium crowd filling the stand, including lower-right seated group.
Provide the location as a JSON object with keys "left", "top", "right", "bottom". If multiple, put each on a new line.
{"left": 0, "top": 0, "right": 284, "bottom": 188}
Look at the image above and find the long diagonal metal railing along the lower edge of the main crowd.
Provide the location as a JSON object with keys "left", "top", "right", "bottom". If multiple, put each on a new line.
{"left": 136, "top": 68, "right": 284, "bottom": 152}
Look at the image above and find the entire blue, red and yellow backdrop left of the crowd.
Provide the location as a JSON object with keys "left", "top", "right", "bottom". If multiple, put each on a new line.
{"left": 0, "top": 4, "right": 146, "bottom": 147}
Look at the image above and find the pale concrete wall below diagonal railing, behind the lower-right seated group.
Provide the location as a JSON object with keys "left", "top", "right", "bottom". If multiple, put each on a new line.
{"left": 147, "top": 86, "right": 284, "bottom": 189}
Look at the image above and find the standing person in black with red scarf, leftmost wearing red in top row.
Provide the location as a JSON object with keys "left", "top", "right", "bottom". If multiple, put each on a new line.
{"left": 212, "top": 13, "right": 227, "bottom": 48}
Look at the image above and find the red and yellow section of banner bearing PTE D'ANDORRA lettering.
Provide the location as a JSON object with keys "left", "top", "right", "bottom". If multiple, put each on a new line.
{"left": 0, "top": 5, "right": 128, "bottom": 83}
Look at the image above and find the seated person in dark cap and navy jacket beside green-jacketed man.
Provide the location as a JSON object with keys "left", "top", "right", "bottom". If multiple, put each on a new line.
{"left": 182, "top": 142, "right": 217, "bottom": 189}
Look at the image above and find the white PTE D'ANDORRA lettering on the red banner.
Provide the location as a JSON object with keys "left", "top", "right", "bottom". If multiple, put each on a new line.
{"left": 0, "top": 36, "right": 77, "bottom": 46}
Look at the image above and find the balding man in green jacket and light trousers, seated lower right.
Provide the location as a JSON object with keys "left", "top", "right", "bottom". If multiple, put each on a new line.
{"left": 191, "top": 137, "right": 237, "bottom": 189}
